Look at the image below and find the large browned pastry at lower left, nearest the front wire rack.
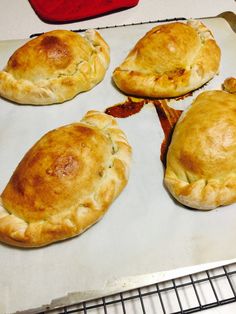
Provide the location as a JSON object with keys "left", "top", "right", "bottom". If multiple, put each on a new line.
{"left": 0, "top": 111, "right": 131, "bottom": 247}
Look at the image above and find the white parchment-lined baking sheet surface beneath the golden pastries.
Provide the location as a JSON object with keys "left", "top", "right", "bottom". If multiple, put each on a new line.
{"left": 0, "top": 18, "right": 236, "bottom": 313}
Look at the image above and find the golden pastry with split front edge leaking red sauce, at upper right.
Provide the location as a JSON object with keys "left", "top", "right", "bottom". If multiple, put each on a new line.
{"left": 113, "top": 20, "right": 221, "bottom": 98}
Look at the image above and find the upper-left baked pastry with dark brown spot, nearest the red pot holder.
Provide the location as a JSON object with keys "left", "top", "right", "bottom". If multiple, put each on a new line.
{"left": 0, "top": 30, "right": 110, "bottom": 105}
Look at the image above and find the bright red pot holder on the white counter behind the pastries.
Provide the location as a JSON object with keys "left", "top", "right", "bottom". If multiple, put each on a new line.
{"left": 29, "top": 0, "right": 139, "bottom": 23}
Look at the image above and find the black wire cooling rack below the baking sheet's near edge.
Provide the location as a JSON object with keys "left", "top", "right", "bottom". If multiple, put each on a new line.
{"left": 38, "top": 264, "right": 236, "bottom": 314}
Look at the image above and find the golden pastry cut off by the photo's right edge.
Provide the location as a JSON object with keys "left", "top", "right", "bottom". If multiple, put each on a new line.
{"left": 164, "top": 91, "right": 236, "bottom": 210}
